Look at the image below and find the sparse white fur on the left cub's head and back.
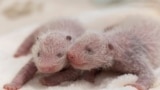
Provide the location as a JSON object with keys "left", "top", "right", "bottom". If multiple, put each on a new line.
{"left": 32, "top": 19, "right": 84, "bottom": 72}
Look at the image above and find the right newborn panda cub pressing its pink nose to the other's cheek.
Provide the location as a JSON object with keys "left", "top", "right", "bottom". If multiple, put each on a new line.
{"left": 67, "top": 16, "right": 160, "bottom": 90}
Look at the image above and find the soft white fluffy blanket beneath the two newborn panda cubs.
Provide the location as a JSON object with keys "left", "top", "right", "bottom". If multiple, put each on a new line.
{"left": 0, "top": 7, "right": 160, "bottom": 90}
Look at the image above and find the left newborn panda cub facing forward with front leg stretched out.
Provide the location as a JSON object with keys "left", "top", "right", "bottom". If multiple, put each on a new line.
{"left": 4, "top": 19, "right": 97, "bottom": 90}
